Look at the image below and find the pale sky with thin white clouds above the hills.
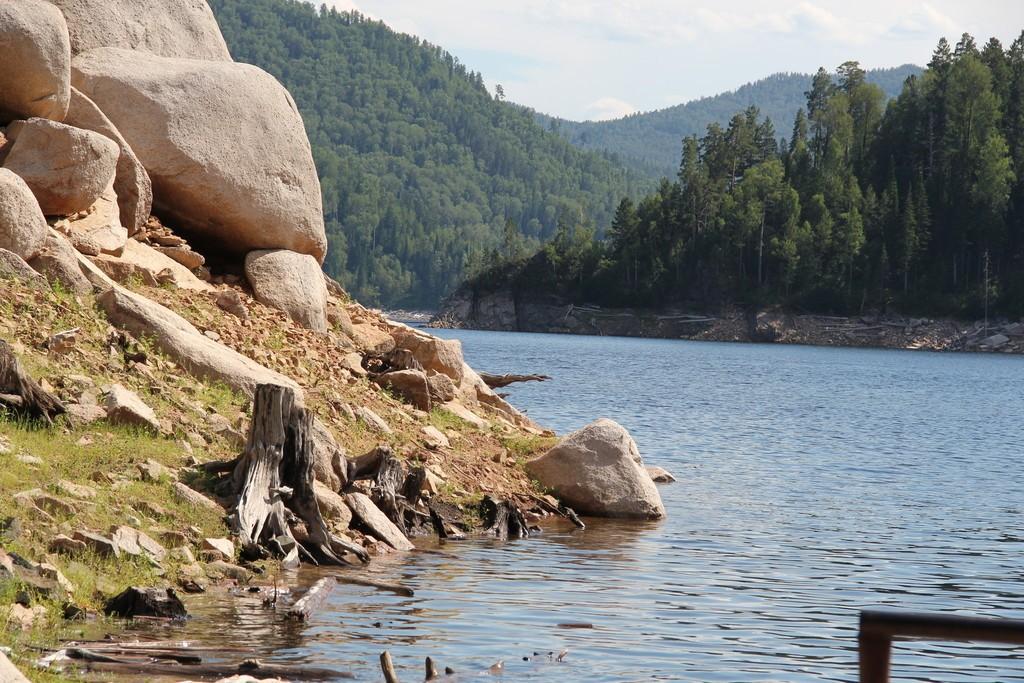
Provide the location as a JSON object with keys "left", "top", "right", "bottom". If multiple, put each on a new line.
{"left": 316, "top": 0, "right": 1024, "bottom": 120}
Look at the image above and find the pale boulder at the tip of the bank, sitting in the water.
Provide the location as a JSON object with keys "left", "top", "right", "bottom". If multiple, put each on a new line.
{"left": 526, "top": 419, "right": 665, "bottom": 519}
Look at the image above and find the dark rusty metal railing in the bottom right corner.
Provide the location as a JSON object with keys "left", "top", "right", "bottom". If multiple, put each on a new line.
{"left": 858, "top": 610, "right": 1024, "bottom": 683}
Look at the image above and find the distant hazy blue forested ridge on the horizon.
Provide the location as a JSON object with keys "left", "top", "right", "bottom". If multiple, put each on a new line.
{"left": 537, "top": 65, "right": 921, "bottom": 175}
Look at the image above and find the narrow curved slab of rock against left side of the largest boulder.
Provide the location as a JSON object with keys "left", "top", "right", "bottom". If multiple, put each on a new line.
{"left": 65, "top": 88, "right": 153, "bottom": 234}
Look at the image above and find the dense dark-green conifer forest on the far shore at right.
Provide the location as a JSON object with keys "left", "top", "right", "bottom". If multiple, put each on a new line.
{"left": 469, "top": 34, "right": 1024, "bottom": 323}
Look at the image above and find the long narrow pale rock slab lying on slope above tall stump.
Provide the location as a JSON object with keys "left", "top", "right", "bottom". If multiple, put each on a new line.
{"left": 93, "top": 284, "right": 303, "bottom": 402}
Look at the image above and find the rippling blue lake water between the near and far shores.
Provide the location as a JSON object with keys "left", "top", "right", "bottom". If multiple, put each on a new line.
{"left": 157, "top": 331, "right": 1024, "bottom": 683}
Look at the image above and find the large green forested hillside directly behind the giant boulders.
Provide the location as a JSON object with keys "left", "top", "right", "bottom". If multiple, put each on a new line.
{"left": 210, "top": 0, "right": 643, "bottom": 306}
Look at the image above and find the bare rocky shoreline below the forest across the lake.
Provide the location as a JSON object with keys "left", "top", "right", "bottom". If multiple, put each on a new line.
{"left": 428, "top": 291, "right": 1024, "bottom": 353}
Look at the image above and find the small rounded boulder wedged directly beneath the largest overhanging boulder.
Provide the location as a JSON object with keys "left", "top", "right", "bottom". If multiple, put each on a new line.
{"left": 246, "top": 249, "right": 327, "bottom": 332}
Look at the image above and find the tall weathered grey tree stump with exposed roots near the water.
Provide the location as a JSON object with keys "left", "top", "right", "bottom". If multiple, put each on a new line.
{"left": 230, "top": 384, "right": 367, "bottom": 567}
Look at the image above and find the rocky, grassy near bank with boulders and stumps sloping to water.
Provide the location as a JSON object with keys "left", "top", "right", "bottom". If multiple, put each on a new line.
{"left": 0, "top": 0, "right": 665, "bottom": 683}
